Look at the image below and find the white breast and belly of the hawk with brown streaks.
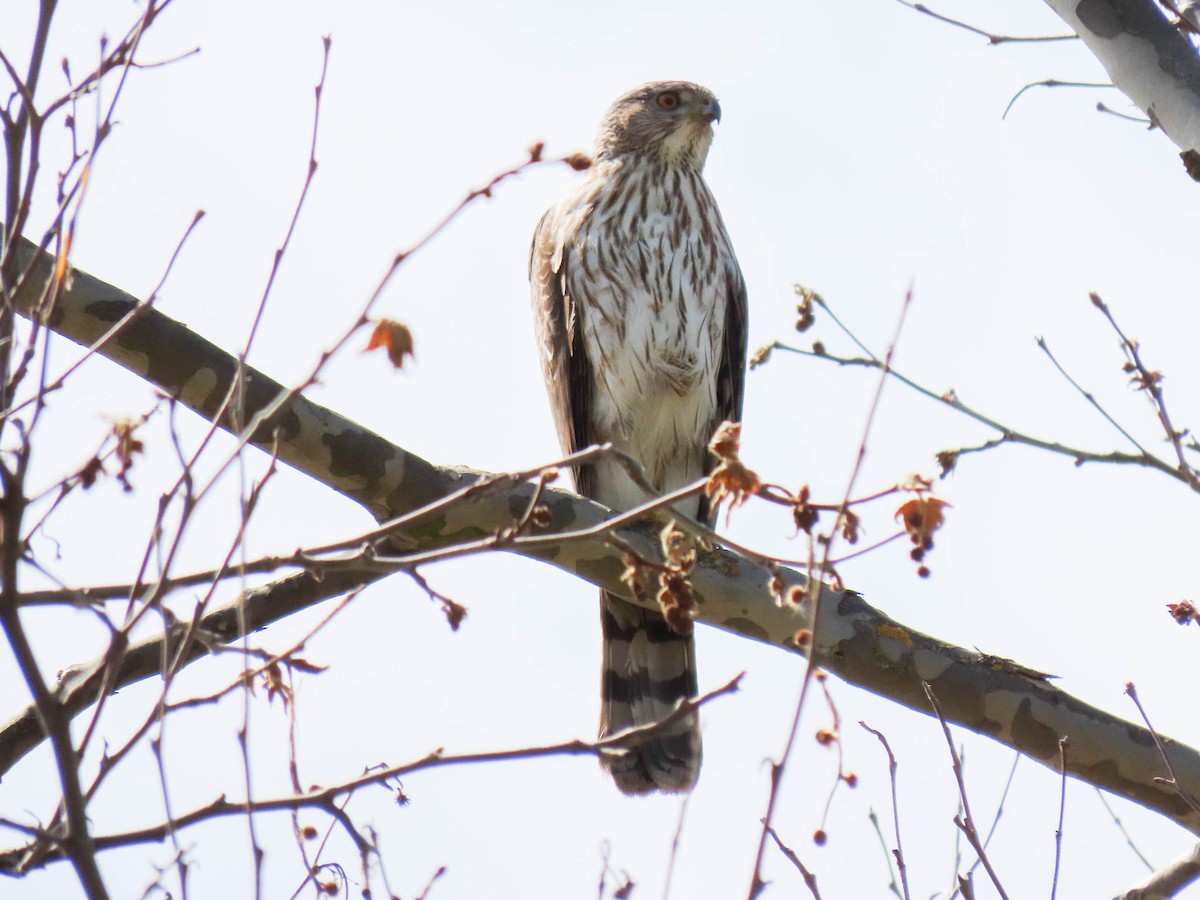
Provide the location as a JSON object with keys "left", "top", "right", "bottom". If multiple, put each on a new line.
{"left": 568, "top": 174, "right": 732, "bottom": 480}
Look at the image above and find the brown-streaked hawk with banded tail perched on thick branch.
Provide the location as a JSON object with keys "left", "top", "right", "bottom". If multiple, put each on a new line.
{"left": 529, "top": 82, "right": 746, "bottom": 794}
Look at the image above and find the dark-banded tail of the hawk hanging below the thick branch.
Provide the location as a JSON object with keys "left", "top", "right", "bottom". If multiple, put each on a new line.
{"left": 600, "top": 594, "right": 701, "bottom": 794}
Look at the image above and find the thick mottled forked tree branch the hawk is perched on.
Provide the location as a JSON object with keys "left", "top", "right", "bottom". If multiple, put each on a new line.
{"left": 7, "top": 245, "right": 1200, "bottom": 834}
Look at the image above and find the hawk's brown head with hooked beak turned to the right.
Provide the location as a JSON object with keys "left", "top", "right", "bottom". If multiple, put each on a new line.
{"left": 596, "top": 82, "right": 721, "bottom": 172}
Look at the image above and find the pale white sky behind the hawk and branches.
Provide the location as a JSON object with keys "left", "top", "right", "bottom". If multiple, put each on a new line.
{"left": 0, "top": 0, "right": 1200, "bottom": 900}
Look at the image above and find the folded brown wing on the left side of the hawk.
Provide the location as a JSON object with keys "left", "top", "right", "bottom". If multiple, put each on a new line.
{"left": 529, "top": 208, "right": 595, "bottom": 497}
